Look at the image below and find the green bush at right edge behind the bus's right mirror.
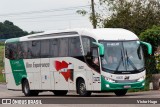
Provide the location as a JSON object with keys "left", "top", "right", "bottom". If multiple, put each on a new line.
{"left": 140, "top": 26, "right": 160, "bottom": 74}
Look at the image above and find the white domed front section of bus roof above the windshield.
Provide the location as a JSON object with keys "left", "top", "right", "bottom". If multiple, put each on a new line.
{"left": 81, "top": 28, "right": 139, "bottom": 41}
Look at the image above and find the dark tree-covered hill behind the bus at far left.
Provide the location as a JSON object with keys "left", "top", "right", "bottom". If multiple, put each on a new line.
{"left": 0, "top": 20, "right": 28, "bottom": 39}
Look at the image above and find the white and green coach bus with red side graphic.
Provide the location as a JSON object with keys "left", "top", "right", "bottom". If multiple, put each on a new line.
{"left": 5, "top": 28, "right": 152, "bottom": 96}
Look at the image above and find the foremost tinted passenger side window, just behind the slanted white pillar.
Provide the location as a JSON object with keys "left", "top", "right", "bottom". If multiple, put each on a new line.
{"left": 69, "top": 37, "right": 82, "bottom": 56}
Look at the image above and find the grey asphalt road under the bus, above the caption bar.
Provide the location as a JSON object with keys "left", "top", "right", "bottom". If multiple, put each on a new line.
{"left": 0, "top": 84, "right": 160, "bottom": 98}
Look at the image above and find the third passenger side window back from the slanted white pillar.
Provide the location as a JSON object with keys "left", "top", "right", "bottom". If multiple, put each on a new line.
{"left": 50, "top": 39, "right": 59, "bottom": 57}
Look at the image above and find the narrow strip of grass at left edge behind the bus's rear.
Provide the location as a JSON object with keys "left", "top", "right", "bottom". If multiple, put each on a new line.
{"left": 0, "top": 45, "right": 5, "bottom": 82}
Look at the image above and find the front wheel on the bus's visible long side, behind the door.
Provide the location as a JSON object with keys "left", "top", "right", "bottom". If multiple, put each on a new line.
{"left": 77, "top": 79, "right": 91, "bottom": 96}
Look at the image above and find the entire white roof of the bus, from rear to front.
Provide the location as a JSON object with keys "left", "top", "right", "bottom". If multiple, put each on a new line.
{"left": 6, "top": 28, "right": 139, "bottom": 43}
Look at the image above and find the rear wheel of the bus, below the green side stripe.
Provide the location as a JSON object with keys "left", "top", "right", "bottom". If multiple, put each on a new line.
{"left": 22, "top": 79, "right": 39, "bottom": 96}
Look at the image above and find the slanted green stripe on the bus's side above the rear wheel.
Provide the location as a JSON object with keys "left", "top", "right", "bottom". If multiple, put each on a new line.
{"left": 10, "top": 59, "right": 27, "bottom": 85}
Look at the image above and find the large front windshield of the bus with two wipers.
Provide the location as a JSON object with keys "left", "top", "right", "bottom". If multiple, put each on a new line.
{"left": 100, "top": 41, "right": 144, "bottom": 72}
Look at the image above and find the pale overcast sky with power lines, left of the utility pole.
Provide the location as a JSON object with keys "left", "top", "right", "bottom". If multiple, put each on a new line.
{"left": 0, "top": 0, "right": 99, "bottom": 32}
